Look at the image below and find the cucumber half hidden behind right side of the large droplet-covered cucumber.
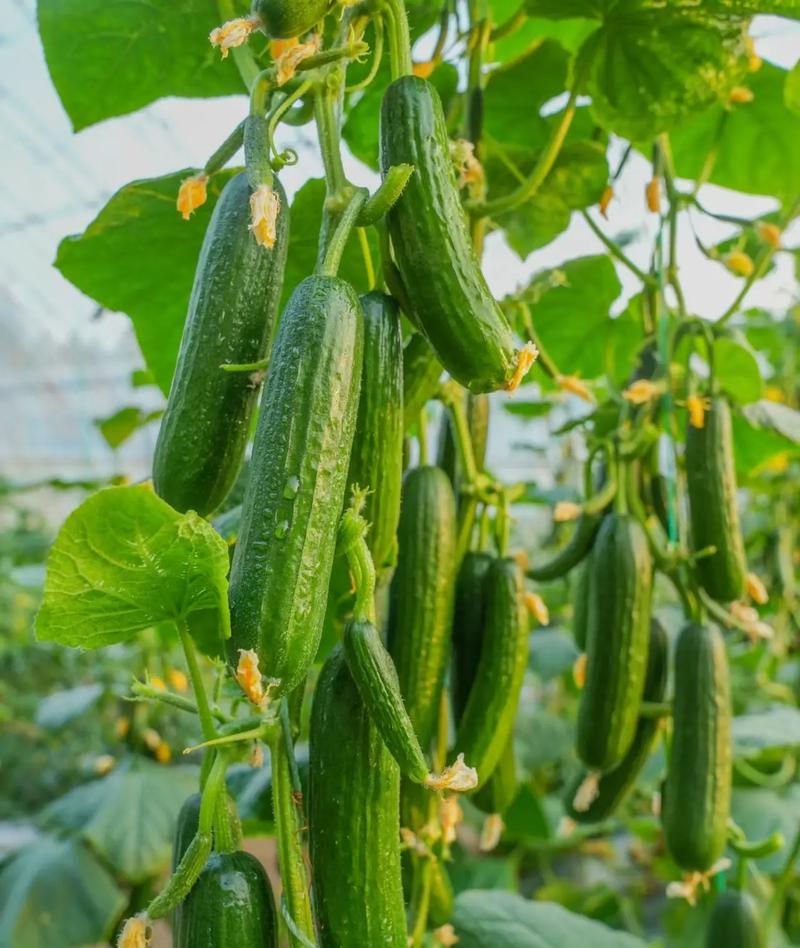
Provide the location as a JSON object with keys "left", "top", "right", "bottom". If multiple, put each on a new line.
{"left": 348, "top": 293, "right": 403, "bottom": 569}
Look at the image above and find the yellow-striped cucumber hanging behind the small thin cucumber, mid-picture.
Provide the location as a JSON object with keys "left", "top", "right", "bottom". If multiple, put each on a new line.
{"left": 389, "top": 467, "right": 456, "bottom": 751}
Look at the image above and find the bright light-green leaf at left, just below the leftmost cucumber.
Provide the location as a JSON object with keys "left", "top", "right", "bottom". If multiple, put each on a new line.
{"left": 36, "top": 486, "right": 230, "bottom": 655}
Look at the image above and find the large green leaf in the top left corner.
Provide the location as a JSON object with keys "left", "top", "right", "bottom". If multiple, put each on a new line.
{"left": 39, "top": 0, "right": 244, "bottom": 131}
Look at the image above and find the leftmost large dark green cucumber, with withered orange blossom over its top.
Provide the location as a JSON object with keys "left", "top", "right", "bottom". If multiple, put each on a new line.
{"left": 153, "top": 174, "right": 289, "bottom": 516}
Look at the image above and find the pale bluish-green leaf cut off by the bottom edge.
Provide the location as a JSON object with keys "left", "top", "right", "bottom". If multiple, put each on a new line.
{"left": 453, "top": 891, "right": 646, "bottom": 948}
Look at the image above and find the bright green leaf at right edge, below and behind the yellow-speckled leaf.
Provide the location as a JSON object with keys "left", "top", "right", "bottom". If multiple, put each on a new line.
{"left": 671, "top": 62, "right": 800, "bottom": 200}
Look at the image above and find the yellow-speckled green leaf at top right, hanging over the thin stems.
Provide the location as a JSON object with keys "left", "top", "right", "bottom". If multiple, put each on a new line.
{"left": 577, "top": 8, "right": 745, "bottom": 141}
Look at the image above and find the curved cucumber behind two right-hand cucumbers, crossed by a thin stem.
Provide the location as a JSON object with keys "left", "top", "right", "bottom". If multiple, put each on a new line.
{"left": 564, "top": 619, "right": 669, "bottom": 823}
